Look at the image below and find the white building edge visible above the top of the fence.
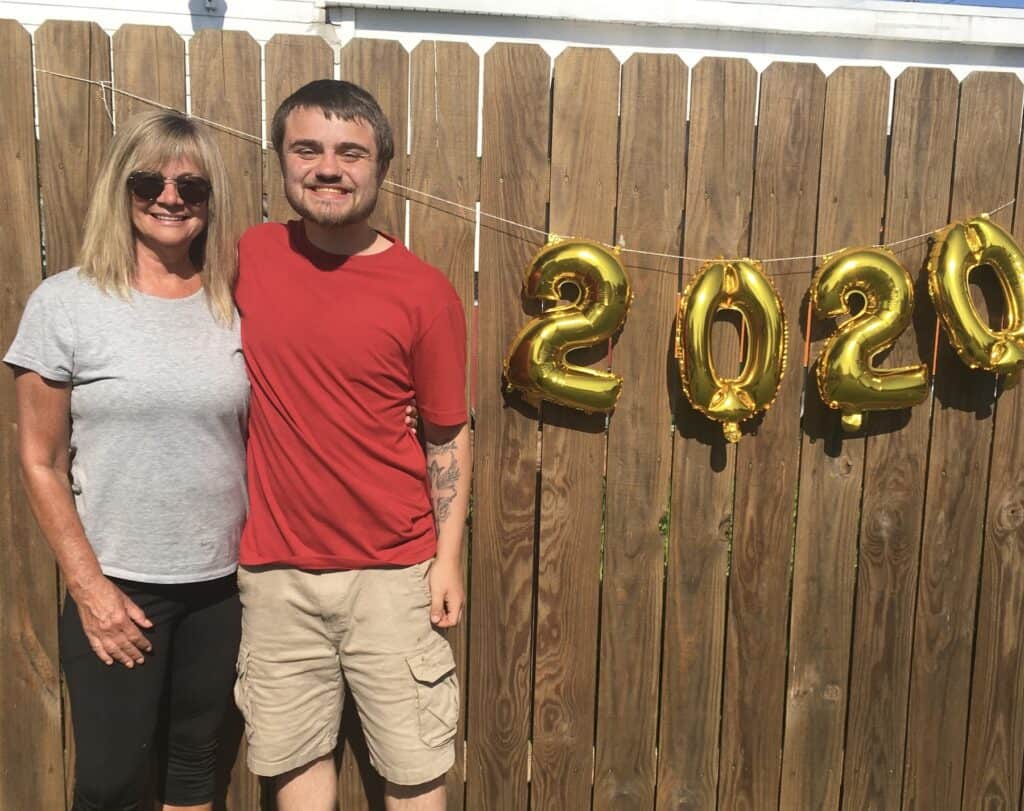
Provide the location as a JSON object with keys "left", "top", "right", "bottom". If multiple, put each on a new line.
{"left": 6, "top": 0, "right": 1024, "bottom": 80}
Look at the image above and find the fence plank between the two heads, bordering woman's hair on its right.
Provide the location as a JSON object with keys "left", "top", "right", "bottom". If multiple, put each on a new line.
{"left": 188, "top": 30, "right": 263, "bottom": 809}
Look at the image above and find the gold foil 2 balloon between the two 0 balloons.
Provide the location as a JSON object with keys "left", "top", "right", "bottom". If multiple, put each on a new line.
{"left": 811, "top": 248, "right": 929, "bottom": 431}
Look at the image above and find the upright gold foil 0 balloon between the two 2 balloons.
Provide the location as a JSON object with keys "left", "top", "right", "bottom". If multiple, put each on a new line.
{"left": 676, "top": 259, "right": 787, "bottom": 442}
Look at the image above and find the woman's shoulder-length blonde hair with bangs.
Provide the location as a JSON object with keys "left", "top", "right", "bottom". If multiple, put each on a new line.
{"left": 80, "top": 111, "right": 239, "bottom": 324}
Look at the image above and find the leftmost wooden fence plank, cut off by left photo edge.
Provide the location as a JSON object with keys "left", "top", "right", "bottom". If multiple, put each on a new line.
{"left": 0, "top": 20, "right": 65, "bottom": 809}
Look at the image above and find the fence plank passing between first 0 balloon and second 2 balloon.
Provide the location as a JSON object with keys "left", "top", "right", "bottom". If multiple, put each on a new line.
{"left": 723, "top": 62, "right": 825, "bottom": 808}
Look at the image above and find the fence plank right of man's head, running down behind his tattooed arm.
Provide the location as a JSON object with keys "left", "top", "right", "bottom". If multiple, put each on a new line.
{"left": 409, "top": 42, "right": 477, "bottom": 811}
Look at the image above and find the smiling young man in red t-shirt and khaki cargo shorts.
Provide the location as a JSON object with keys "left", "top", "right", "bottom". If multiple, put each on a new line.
{"left": 236, "top": 80, "right": 470, "bottom": 811}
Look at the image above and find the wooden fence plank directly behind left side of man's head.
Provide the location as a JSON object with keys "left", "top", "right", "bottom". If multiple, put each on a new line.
{"left": 263, "top": 34, "right": 334, "bottom": 222}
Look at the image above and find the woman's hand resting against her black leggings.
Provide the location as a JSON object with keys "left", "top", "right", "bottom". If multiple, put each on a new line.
{"left": 72, "top": 577, "right": 153, "bottom": 668}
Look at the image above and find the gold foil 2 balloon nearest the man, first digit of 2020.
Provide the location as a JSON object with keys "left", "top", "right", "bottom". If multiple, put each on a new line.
{"left": 505, "top": 238, "right": 633, "bottom": 414}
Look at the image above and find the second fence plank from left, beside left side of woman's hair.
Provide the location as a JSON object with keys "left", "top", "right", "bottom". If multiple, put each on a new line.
{"left": 35, "top": 20, "right": 112, "bottom": 273}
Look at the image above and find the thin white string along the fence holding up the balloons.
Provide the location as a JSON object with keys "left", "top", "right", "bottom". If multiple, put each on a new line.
{"left": 34, "top": 68, "right": 1017, "bottom": 275}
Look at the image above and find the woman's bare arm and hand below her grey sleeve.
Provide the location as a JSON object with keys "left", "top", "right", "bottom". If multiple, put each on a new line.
{"left": 14, "top": 370, "right": 153, "bottom": 668}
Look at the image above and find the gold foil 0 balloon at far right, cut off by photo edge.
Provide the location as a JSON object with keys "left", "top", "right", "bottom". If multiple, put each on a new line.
{"left": 928, "top": 215, "right": 1024, "bottom": 378}
